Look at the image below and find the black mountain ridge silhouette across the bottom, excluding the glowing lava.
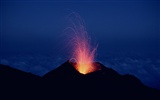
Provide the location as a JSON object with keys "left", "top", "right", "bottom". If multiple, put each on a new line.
{"left": 0, "top": 61, "right": 160, "bottom": 100}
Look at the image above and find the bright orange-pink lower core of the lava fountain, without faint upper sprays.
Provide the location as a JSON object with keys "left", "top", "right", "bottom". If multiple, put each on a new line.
{"left": 74, "top": 37, "right": 96, "bottom": 74}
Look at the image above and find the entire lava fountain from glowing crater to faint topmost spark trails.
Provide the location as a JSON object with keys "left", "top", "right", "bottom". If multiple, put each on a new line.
{"left": 68, "top": 13, "right": 98, "bottom": 74}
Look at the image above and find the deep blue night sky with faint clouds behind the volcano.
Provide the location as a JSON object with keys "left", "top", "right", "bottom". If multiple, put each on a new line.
{"left": 0, "top": 0, "right": 160, "bottom": 89}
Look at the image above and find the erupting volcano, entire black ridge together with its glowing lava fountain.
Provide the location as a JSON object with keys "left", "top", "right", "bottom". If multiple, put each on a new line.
{"left": 0, "top": 13, "right": 160, "bottom": 100}
